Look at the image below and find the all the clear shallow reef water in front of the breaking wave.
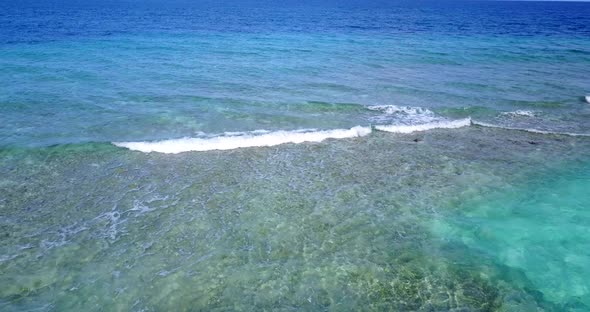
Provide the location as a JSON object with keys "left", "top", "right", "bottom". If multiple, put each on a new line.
{"left": 0, "top": 127, "right": 590, "bottom": 311}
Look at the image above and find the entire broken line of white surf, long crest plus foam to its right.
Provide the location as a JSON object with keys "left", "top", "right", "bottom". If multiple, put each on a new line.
{"left": 112, "top": 105, "right": 590, "bottom": 154}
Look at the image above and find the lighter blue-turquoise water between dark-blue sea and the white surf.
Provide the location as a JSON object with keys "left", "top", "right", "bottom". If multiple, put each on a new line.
{"left": 0, "top": 33, "right": 590, "bottom": 146}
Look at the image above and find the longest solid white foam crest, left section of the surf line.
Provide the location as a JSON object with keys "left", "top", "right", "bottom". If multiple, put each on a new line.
{"left": 113, "top": 126, "right": 371, "bottom": 154}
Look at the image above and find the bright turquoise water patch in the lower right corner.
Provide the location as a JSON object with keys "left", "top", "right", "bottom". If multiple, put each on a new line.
{"left": 434, "top": 161, "right": 590, "bottom": 311}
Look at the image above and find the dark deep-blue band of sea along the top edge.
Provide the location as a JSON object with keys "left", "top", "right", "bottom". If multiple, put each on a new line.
{"left": 0, "top": 1, "right": 590, "bottom": 43}
